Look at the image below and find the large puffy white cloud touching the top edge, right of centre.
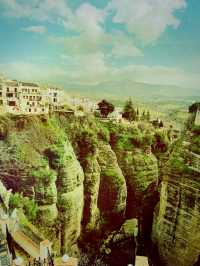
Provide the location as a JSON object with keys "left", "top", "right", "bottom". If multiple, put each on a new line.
{"left": 106, "top": 0, "right": 186, "bottom": 42}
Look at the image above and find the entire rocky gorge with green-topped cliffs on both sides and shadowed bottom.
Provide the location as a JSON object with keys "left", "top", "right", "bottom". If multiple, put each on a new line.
{"left": 0, "top": 104, "right": 200, "bottom": 266}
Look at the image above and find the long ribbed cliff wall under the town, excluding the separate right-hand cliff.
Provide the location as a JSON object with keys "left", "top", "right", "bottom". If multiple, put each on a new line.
{"left": 0, "top": 113, "right": 161, "bottom": 265}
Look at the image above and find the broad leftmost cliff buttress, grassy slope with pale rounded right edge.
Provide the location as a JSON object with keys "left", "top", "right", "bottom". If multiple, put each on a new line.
{"left": 0, "top": 116, "right": 84, "bottom": 254}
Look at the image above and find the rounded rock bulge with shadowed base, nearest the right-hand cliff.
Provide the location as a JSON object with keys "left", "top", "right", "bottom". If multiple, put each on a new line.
{"left": 117, "top": 149, "right": 158, "bottom": 218}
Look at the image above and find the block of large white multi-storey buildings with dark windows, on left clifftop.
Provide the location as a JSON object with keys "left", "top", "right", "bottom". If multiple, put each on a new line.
{"left": 0, "top": 79, "right": 64, "bottom": 114}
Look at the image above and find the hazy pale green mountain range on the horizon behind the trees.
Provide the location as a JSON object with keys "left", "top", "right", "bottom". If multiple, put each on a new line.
{"left": 65, "top": 80, "right": 200, "bottom": 102}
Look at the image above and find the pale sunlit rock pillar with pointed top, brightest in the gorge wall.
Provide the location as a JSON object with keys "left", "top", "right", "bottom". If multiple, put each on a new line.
{"left": 54, "top": 143, "right": 84, "bottom": 254}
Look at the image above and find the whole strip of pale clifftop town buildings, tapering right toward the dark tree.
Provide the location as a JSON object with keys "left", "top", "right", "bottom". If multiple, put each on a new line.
{"left": 0, "top": 77, "right": 97, "bottom": 114}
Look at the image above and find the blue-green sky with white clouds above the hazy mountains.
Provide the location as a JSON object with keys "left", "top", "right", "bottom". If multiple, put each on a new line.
{"left": 0, "top": 0, "right": 200, "bottom": 89}
